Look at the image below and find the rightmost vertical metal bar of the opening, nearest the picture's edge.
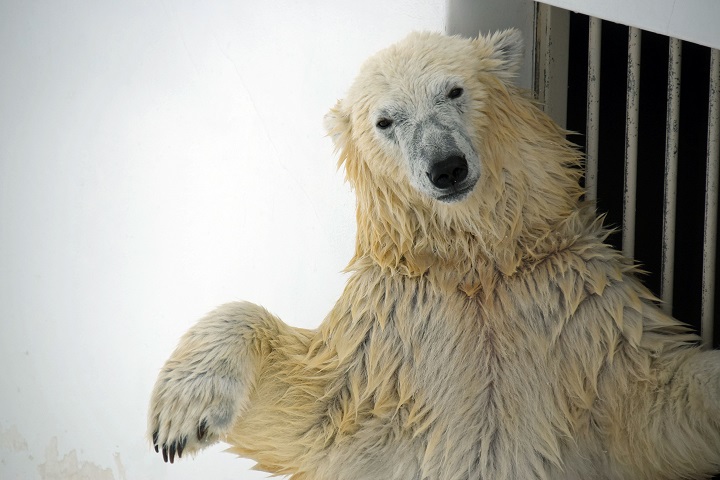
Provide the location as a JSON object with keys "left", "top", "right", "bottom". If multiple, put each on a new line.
{"left": 700, "top": 49, "right": 720, "bottom": 348}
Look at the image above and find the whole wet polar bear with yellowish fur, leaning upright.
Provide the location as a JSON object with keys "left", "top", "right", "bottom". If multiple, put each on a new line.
{"left": 149, "top": 30, "right": 720, "bottom": 480}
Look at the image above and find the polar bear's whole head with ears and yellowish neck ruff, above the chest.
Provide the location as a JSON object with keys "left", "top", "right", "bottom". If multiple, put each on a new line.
{"left": 325, "top": 30, "right": 581, "bottom": 282}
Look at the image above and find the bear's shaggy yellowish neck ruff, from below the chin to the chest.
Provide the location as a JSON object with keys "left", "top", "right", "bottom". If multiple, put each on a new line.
{"left": 348, "top": 143, "right": 584, "bottom": 294}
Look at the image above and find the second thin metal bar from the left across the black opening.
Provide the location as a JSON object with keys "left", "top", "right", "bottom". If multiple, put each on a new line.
{"left": 622, "top": 27, "right": 641, "bottom": 258}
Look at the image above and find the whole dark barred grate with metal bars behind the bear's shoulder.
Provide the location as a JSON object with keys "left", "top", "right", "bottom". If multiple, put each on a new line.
{"left": 535, "top": 4, "right": 720, "bottom": 347}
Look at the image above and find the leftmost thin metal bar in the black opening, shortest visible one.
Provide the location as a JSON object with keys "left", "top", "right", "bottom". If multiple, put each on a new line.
{"left": 585, "top": 17, "right": 602, "bottom": 202}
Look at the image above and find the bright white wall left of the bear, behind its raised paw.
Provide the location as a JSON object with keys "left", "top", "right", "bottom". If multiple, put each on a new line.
{"left": 0, "top": 0, "right": 529, "bottom": 479}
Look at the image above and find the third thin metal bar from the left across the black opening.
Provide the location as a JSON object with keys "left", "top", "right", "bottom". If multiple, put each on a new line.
{"left": 660, "top": 38, "right": 682, "bottom": 314}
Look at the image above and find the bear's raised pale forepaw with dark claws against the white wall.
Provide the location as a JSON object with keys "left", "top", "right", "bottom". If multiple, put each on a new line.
{"left": 148, "top": 302, "right": 282, "bottom": 463}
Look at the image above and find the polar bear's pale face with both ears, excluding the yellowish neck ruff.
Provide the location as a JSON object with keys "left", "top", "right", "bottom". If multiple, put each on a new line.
{"left": 326, "top": 30, "right": 522, "bottom": 203}
